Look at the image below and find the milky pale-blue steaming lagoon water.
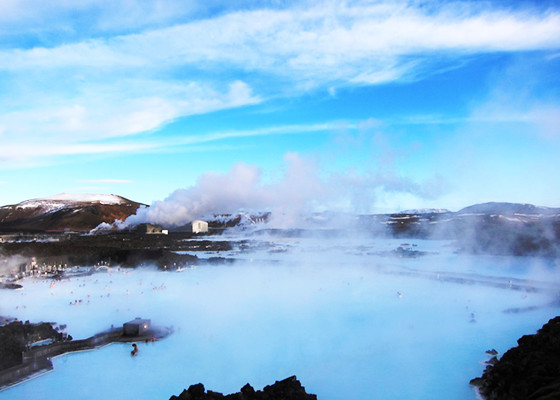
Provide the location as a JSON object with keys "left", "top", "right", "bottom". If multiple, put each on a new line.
{"left": 0, "top": 237, "right": 560, "bottom": 400}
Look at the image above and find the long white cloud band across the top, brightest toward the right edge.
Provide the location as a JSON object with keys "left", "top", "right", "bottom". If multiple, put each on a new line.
{"left": 0, "top": 3, "right": 560, "bottom": 72}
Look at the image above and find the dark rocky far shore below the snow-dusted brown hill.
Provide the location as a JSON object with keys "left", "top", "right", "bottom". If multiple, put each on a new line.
{"left": 0, "top": 233, "right": 238, "bottom": 282}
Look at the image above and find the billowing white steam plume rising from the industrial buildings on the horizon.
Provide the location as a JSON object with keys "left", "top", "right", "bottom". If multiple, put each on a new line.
{"left": 121, "top": 153, "right": 442, "bottom": 227}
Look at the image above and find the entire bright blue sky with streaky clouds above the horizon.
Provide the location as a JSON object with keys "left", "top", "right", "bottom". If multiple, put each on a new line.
{"left": 0, "top": 0, "right": 560, "bottom": 212}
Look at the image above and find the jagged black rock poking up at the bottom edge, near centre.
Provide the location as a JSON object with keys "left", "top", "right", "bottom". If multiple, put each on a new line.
{"left": 169, "top": 376, "right": 317, "bottom": 400}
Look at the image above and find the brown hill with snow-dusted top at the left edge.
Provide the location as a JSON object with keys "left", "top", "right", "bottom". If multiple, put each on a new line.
{"left": 0, "top": 193, "right": 142, "bottom": 232}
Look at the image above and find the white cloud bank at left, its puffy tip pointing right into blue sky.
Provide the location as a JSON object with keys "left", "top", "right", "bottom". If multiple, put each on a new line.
{"left": 0, "top": 80, "right": 260, "bottom": 144}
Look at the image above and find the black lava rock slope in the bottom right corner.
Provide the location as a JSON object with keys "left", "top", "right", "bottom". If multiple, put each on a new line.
{"left": 471, "top": 316, "right": 560, "bottom": 400}
